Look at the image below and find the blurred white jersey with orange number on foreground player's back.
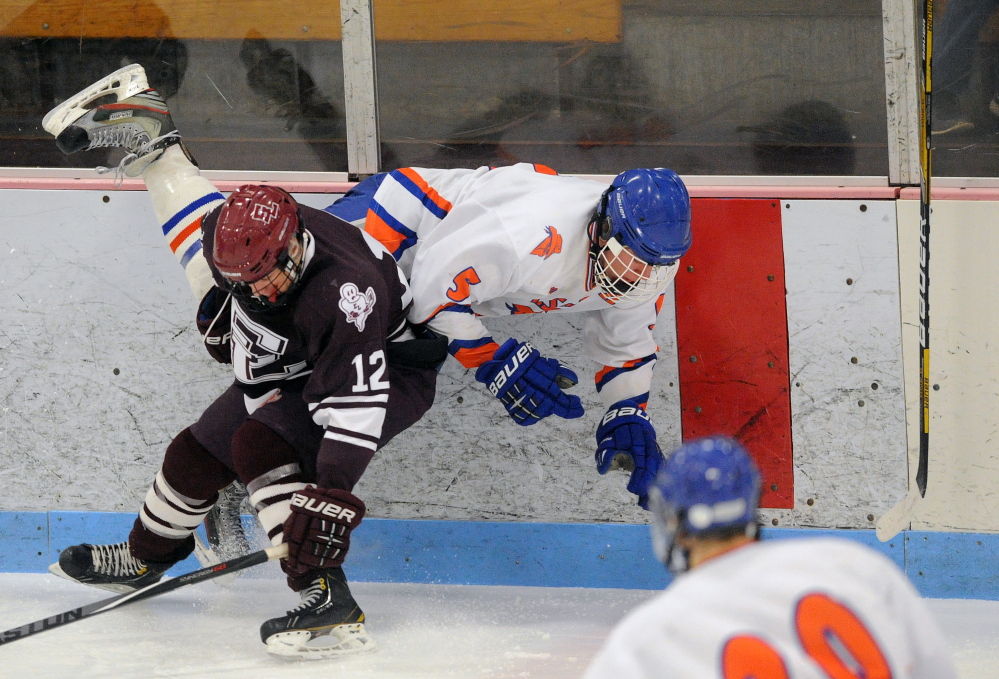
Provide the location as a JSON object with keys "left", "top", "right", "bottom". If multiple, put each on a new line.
{"left": 584, "top": 538, "right": 957, "bottom": 679}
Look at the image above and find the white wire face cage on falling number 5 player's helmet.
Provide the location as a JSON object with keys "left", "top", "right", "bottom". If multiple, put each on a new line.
{"left": 593, "top": 237, "right": 680, "bottom": 309}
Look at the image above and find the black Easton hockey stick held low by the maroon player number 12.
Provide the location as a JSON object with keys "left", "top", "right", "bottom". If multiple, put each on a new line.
{"left": 0, "top": 544, "right": 288, "bottom": 645}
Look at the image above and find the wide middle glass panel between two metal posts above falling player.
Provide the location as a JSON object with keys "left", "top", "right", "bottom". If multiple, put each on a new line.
{"left": 374, "top": 0, "right": 888, "bottom": 176}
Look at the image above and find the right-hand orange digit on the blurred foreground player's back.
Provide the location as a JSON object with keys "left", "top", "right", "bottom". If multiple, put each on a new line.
{"left": 794, "top": 594, "right": 891, "bottom": 679}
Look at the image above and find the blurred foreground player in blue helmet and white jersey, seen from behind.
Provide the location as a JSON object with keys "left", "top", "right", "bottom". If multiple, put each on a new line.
{"left": 584, "top": 437, "right": 957, "bottom": 679}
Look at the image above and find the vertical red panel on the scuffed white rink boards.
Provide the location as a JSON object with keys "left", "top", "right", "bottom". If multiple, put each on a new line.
{"left": 676, "top": 198, "right": 794, "bottom": 508}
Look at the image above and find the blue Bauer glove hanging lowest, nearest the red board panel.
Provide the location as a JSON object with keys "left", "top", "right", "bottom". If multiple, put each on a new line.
{"left": 596, "top": 399, "right": 663, "bottom": 509}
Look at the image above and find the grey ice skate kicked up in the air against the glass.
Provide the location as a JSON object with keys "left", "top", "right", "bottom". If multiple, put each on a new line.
{"left": 42, "top": 64, "right": 186, "bottom": 177}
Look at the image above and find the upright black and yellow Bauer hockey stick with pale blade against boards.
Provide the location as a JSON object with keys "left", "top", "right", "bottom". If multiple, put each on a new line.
{"left": 875, "top": 0, "right": 933, "bottom": 542}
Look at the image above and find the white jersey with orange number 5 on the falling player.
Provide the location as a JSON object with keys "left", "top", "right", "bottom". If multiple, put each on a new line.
{"left": 356, "top": 163, "right": 678, "bottom": 406}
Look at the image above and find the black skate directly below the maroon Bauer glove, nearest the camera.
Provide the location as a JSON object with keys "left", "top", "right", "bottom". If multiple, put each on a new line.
{"left": 260, "top": 567, "right": 375, "bottom": 660}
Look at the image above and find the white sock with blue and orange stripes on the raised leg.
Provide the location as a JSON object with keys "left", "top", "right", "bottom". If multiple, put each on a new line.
{"left": 142, "top": 144, "right": 225, "bottom": 301}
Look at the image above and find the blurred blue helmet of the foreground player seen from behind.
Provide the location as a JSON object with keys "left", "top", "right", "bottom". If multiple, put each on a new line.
{"left": 649, "top": 436, "right": 761, "bottom": 572}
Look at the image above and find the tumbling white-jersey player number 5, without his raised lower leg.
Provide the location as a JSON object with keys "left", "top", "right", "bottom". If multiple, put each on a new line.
{"left": 326, "top": 163, "right": 691, "bottom": 507}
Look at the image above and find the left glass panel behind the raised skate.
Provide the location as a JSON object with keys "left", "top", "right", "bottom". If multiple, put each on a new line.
{"left": 0, "top": 0, "right": 347, "bottom": 171}
